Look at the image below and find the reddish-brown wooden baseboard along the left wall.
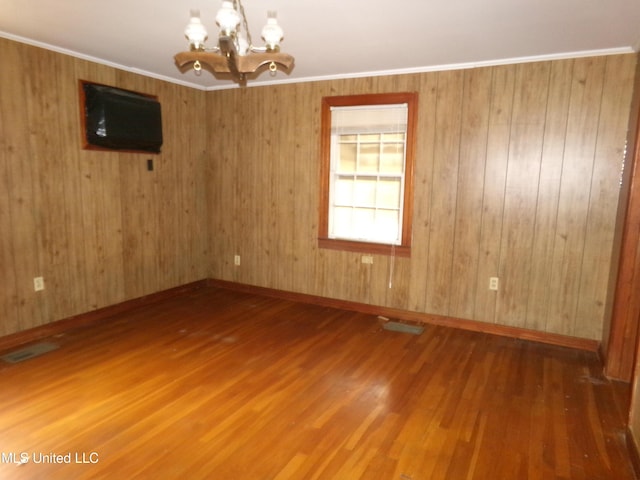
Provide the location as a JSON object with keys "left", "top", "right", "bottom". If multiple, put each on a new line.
{"left": 0, "top": 280, "right": 207, "bottom": 350}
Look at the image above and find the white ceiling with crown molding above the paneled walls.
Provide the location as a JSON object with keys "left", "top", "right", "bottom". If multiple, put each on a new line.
{"left": 0, "top": 0, "right": 640, "bottom": 89}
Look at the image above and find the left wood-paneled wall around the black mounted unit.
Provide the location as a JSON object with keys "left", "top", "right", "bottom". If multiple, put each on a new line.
{"left": 0, "top": 39, "right": 209, "bottom": 335}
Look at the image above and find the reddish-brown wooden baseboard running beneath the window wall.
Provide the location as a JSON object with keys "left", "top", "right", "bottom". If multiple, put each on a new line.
{"left": 207, "top": 279, "right": 600, "bottom": 353}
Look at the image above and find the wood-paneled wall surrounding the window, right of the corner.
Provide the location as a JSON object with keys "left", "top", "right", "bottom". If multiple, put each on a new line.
{"left": 207, "top": 54, "right": 636, "bottom": 340}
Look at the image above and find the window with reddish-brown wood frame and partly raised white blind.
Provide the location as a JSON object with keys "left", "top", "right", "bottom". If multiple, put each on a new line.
{"left": 319, "top": 93, "right": 418, "bottom": 256}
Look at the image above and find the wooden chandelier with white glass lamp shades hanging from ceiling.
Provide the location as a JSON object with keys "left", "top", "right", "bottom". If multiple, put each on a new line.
{"left": 174, "top": 0, "right": 293, "bottom": 85}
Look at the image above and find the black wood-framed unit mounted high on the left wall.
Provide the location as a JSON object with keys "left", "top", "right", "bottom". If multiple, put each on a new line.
{"left": 80, "top": 80, "right": 162, "bottom": 153}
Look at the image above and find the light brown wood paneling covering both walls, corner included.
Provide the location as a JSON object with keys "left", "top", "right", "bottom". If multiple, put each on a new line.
{"left": 0, "top": 35, "right": 636, "bottom": 340}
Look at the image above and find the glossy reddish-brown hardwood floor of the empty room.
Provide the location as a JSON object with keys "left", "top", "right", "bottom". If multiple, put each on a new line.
{"left": 0, "top": 288, "right": 634, "bottom": 480}
